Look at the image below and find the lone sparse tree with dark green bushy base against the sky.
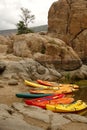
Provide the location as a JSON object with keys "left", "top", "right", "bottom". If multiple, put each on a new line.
{"left": 17, "top": 8, "right": 35, "bottom": 34}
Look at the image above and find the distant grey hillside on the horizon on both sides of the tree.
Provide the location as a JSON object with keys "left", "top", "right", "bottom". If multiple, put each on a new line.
{"left": 0, "top": 25, "right": 48, "bottom": 36}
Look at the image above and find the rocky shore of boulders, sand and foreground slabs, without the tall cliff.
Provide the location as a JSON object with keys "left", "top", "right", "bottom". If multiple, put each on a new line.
{"left": 0, "top": 31, "right": 87, "bottom": 130}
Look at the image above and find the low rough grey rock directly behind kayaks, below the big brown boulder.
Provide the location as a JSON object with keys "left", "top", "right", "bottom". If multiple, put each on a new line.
{"left": 2, "top": 59, "right": 61, "bottom": 81}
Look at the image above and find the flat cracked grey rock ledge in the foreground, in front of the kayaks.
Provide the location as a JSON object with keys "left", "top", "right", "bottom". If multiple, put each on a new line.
{"left": 0, "top": 103, "right": 87, "bottom": 130}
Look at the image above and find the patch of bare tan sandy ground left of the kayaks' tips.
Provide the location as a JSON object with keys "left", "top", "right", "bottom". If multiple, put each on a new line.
{"left": 0, "top": 80, "right": 28, "bottom": 105}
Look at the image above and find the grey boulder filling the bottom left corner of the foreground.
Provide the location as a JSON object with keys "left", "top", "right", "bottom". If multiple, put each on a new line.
{"left": 0, "top": 104, "right": 45, "bottom": 130}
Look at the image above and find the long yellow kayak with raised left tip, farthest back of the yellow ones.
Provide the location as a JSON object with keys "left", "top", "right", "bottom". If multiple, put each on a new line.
{"left": 24, "top": 80, "right": 79, "bottom": 91}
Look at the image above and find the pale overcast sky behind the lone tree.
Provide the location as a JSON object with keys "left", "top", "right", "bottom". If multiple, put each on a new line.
{"left": 0, "top": 0, "right": 57, "bottom": 30}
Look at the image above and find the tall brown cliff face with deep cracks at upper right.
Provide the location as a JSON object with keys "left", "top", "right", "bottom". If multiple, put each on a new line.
{"left": 48, "top": 0, "right": 87, "bottom": 59}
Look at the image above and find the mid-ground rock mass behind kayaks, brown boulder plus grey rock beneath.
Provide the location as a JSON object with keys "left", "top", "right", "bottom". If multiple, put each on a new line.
{"left": 0, "top": 33, "right": 87, "bottom": 79}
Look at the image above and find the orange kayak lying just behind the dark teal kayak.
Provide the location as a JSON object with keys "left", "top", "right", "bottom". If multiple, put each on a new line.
{"left": 29, "top": 87, "right": 76, "bottom": 94}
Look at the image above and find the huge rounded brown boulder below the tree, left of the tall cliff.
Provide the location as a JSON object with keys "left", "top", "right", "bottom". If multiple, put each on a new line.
{"left": 8, "top": 33, "right": 82, "bottom": 70}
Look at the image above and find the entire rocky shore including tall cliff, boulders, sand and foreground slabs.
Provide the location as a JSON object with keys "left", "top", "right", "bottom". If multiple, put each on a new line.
{"left": 0, "top": 0, "right": 87, "bottom": 130}
